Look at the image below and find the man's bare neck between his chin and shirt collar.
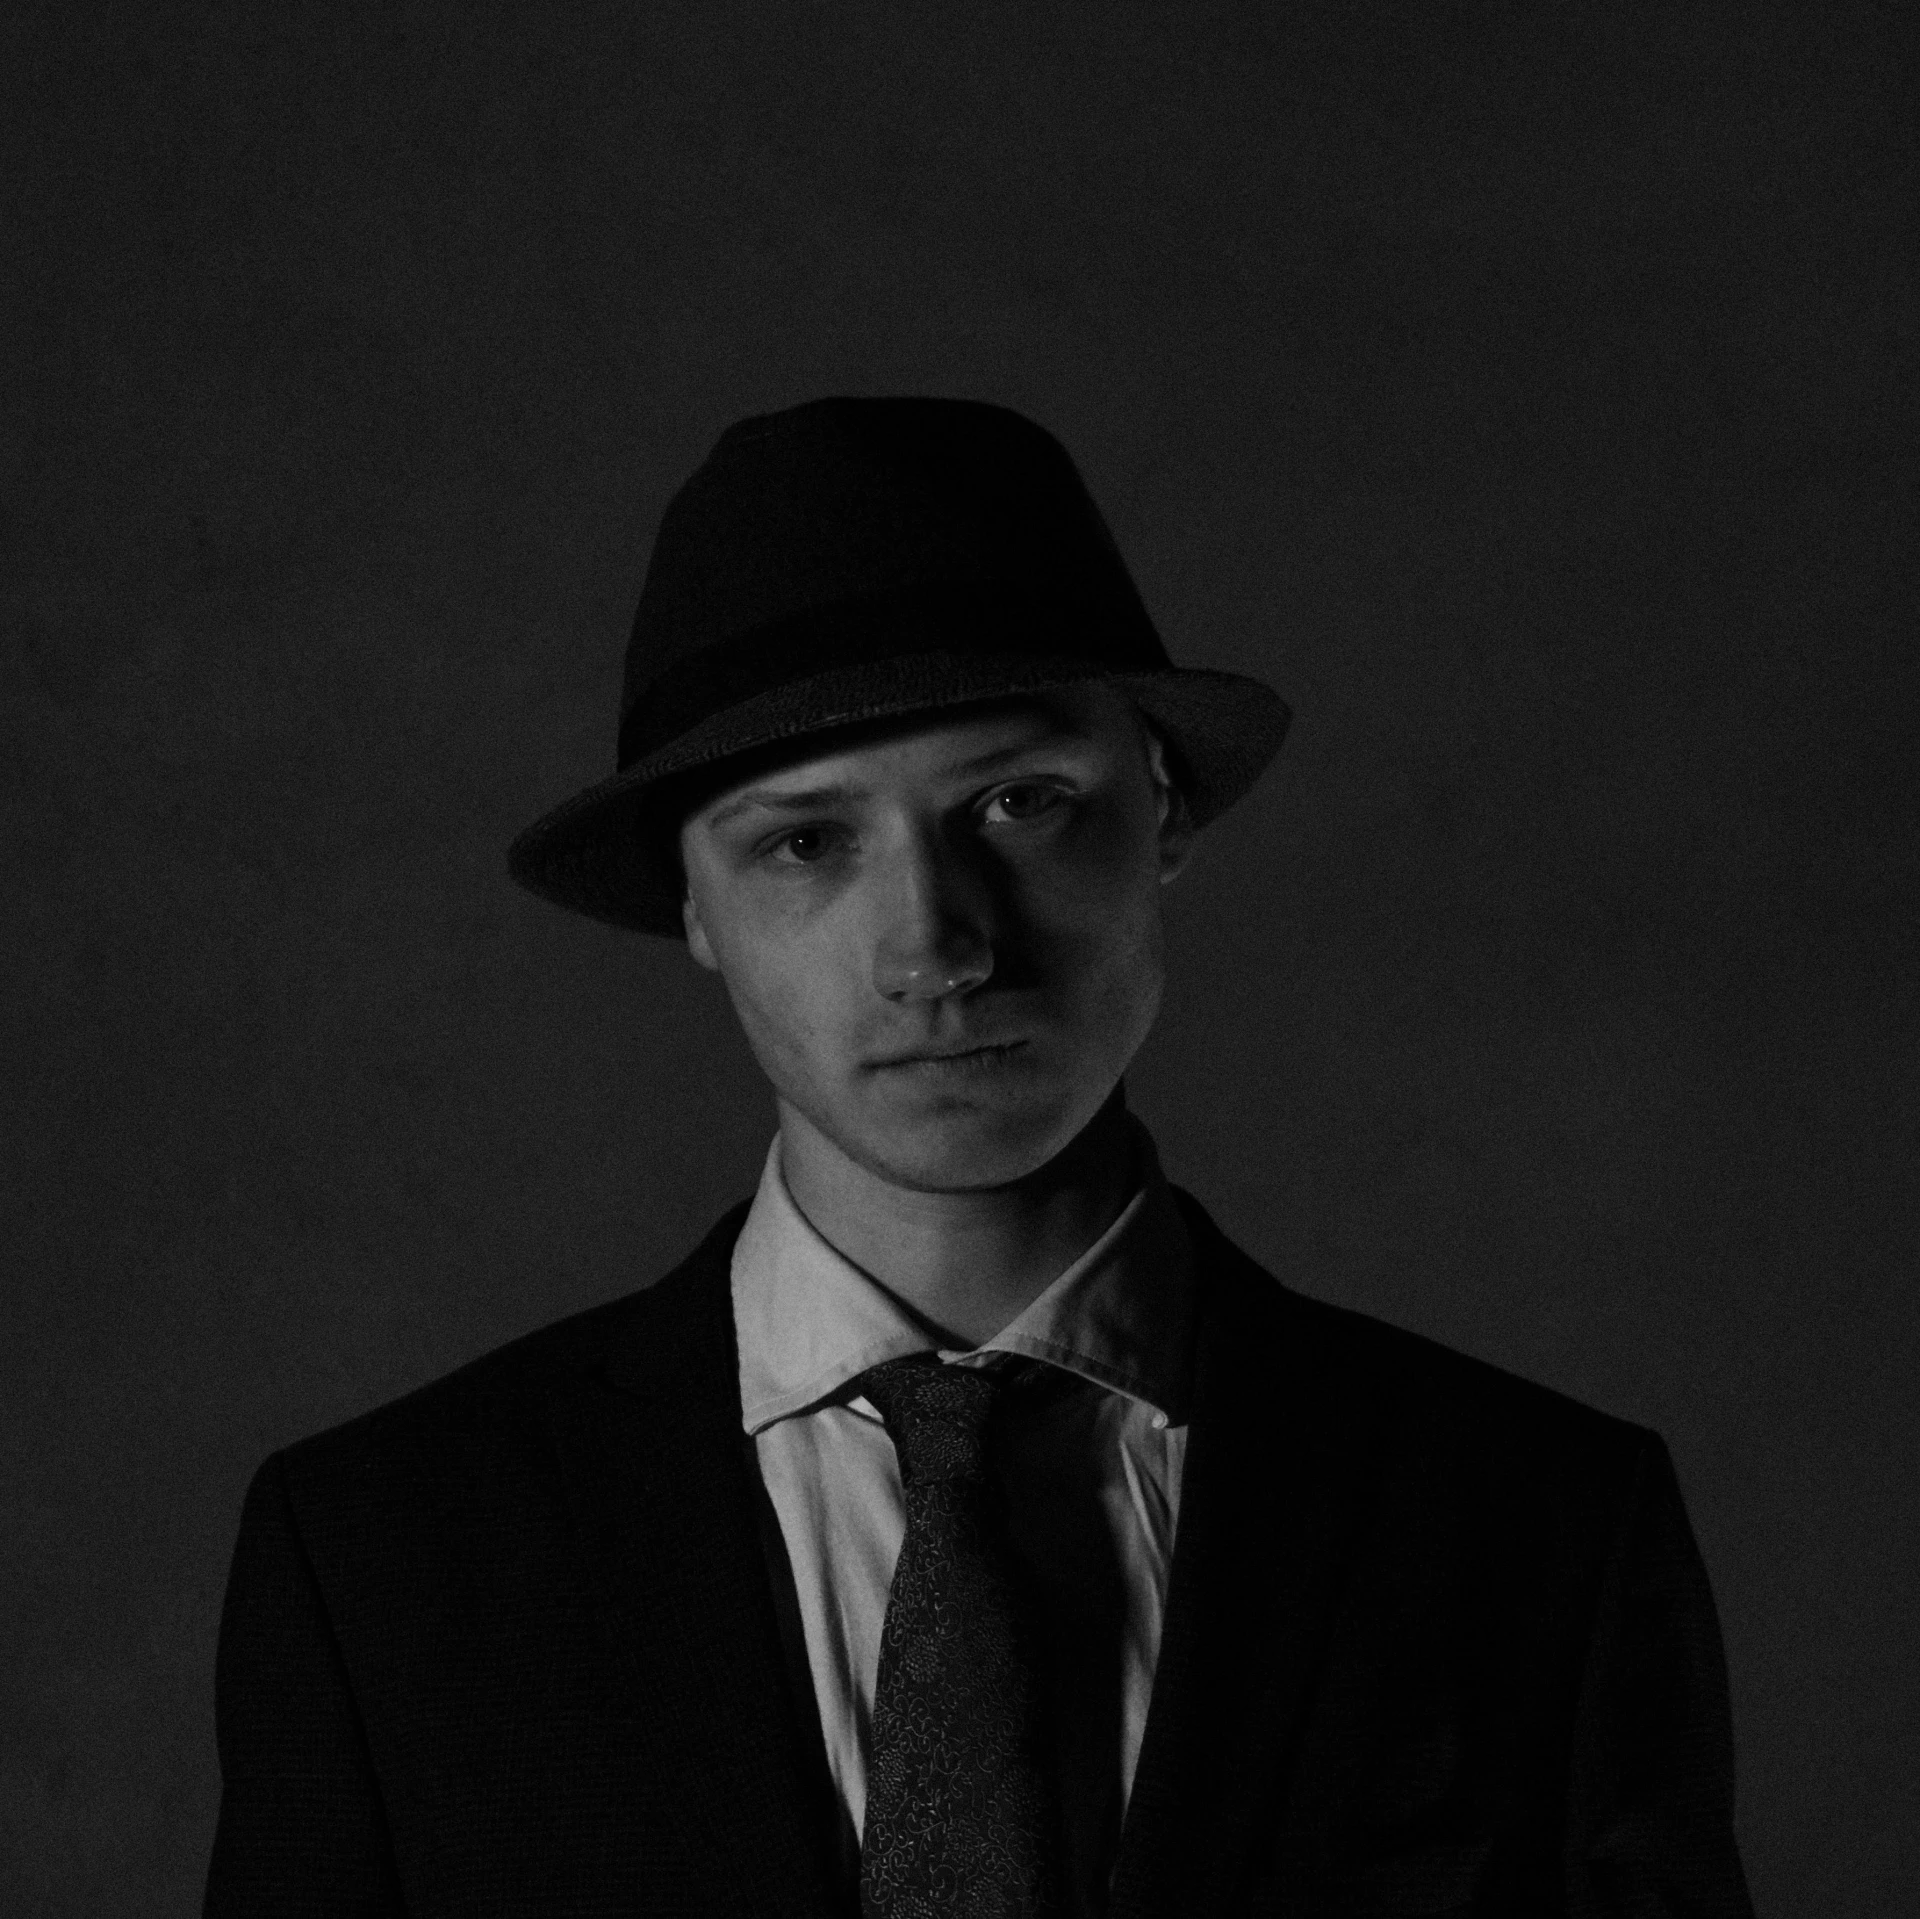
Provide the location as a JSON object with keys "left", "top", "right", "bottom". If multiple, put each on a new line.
{"left": 780, "top": 1087, "right": 1135, "bottom": 1347}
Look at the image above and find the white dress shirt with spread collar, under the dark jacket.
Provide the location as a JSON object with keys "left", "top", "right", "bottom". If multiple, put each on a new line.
{"left": 732, "top": 1122, "right": 1192, "bottom": 1913}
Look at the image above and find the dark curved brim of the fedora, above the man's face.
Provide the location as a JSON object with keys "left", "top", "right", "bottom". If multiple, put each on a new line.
{"left": 507, "top": 653, "right": 1290, "bottom": 939}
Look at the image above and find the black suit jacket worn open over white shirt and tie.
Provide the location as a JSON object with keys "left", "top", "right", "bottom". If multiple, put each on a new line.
{"left": 205, "top": 1193, "right": 1751, "bottom": 1919}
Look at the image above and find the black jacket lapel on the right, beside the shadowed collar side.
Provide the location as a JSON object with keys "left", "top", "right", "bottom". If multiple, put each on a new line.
{"left": 1112, "top": 1193, "right": 1373, "bottom": 1919}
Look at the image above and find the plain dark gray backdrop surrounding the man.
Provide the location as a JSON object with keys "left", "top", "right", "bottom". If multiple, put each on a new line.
{"left": 0, "top": 0, "right": 1920, "bottom": 1919}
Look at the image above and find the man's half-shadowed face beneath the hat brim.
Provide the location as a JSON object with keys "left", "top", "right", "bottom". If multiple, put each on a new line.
{"left": 680, "top": 684, "right": 1190, "bottom": 1191}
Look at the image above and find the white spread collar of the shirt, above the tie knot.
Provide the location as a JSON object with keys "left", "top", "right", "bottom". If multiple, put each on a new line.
{"left": 732, "top": 1122, "right": 1192, "bottom": 1433}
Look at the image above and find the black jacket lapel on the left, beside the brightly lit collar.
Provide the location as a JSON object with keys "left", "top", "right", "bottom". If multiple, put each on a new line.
{"left": 551, "top": 1206, "right": 841, "bottom": 1915}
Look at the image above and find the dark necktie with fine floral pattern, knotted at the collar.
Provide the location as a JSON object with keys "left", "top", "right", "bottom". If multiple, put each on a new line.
{"left": 858, "top": 1354, "right": 1064, "bottom": 1919}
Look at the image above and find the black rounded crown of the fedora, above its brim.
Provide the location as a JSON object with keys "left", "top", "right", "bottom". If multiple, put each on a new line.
{"left": 620, "top": 398, "right": 1165, "bottom": 763}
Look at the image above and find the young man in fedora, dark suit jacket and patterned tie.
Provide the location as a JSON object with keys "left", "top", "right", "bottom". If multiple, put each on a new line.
{"left": 207, "top": 400, "right": 1749, "bottom": 1919}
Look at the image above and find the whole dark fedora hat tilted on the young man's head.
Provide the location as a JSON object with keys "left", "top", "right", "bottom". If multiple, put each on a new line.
{"left": 507, "top": 398, "right": 1288, "bottom": 937}
